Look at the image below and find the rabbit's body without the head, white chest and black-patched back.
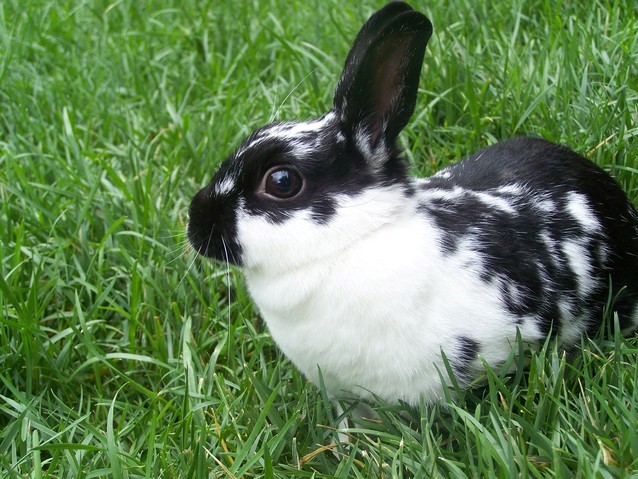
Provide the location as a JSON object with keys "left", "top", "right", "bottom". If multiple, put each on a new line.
{"left": 239, "top": 135, "right": 638, "bottom": 404}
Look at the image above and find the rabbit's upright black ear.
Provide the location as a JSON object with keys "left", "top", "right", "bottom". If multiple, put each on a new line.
{"left": 334, "top": 2, "right": 432, "bottom": 157}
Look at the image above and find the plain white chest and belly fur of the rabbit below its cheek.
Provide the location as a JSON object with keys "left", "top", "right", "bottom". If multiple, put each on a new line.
{"left": 241, "top": 195, "right": 540, "bottom": 404}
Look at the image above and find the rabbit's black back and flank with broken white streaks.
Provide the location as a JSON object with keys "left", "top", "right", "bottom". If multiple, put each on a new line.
{"left": 417, "top": 138, "right": 638, "bottom": 344}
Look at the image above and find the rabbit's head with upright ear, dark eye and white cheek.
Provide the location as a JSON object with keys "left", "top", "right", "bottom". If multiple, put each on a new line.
{"left": 188, "top": 2, "right": 432, "bottom": 271}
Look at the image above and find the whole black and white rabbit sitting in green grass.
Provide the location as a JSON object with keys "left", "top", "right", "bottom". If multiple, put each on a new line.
{"left": 188, "top": 2, "right": 638, "bottom": 405}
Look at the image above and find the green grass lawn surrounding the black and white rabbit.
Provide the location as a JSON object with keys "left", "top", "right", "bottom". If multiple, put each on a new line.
{"left": 0, "top": 0, "right": 638, "bottom": 479}
